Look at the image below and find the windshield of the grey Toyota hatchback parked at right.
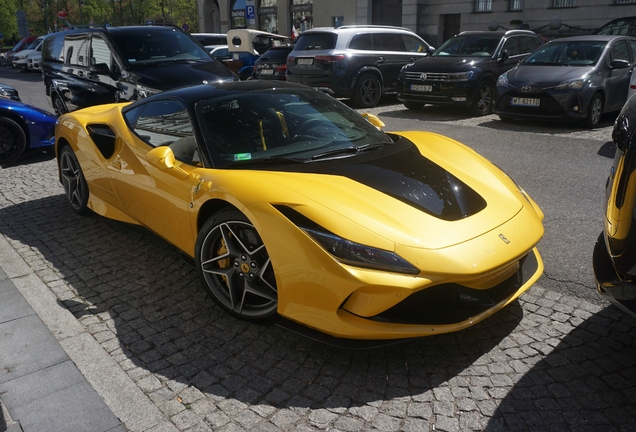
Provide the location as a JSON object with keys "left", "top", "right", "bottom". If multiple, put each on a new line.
{"left": 523, "top": 41, "right": 607, "bottom": 66}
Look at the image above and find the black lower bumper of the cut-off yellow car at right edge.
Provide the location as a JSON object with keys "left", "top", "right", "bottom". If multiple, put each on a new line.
{"left": 592, "top": 233, "right": 636, "bottom": 318}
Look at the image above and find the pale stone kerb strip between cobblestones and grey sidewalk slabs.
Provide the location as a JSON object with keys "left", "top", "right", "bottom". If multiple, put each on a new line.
{"left": 0, "top": 235, "right": 170, "bottom": 431}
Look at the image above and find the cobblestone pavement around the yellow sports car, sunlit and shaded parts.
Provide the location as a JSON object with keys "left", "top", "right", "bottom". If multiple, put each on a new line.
{"left": 0, "top": 151, "right": 636, "bottom": 432}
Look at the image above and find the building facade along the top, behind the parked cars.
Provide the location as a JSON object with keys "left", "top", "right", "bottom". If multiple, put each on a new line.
{"left": 198, "top": 0, "right": 636, "bottom": 46}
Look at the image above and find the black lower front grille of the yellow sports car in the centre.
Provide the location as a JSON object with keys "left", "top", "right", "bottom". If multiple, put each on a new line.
{"left": 371, "top": 251, "right": 539, "bottom": 325}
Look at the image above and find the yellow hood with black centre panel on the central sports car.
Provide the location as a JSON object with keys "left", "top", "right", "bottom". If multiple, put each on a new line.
{"left": 224, "top": 132, "right": 543, "bottom": 249}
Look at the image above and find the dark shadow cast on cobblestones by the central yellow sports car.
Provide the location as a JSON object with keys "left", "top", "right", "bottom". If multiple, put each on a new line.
{"left": 0, "top": 194, "right": 523, "bottom": 410}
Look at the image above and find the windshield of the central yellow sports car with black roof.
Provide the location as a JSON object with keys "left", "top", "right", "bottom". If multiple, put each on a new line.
{"left": 196, "top": 89, "right": 393, "bottom": 168}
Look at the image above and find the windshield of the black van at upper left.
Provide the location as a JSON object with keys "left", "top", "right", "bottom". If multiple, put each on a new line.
{"left": 111, "top": 27, "right": 210, "bottom": 67}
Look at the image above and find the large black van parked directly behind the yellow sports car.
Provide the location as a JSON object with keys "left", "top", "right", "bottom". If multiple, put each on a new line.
{"left": 42, "top": 26, "right": 238, "bottom": 115}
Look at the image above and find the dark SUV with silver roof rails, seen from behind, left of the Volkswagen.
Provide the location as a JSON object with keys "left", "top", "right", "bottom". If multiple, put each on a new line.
{"left": 287, "top": 25, "right": 433, "bottom": 108}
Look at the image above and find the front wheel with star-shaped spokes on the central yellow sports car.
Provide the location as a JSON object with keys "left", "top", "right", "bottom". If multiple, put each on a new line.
{"left": 195, "top": 209, "right": 278, "bottom": 321}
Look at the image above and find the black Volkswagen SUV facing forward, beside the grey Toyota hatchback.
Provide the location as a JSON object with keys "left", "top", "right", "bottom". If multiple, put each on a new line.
{"left": 397, "top": 30, "right": 542, "bottom": 115}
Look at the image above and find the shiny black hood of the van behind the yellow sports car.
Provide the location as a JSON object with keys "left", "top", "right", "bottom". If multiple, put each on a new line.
{"left": 130, "top": 61, "right": 239, "bottom": 90}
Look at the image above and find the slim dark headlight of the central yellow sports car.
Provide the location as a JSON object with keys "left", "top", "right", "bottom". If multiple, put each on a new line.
{"left": 301, "top": 227, "right": 420, "bottom": 274}
